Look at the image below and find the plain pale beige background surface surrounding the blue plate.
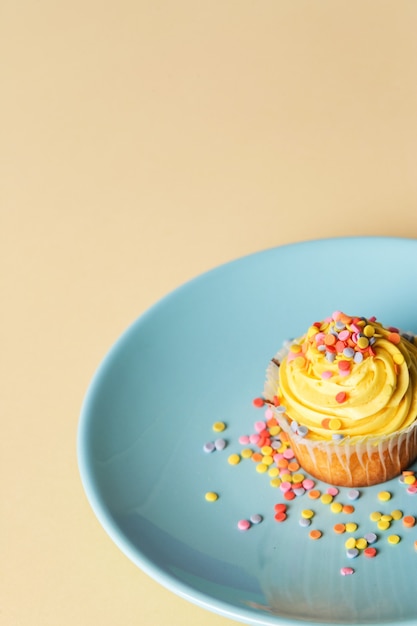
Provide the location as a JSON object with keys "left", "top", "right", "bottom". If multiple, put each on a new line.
{"left": 0, "top": 0, "right": 417, "bottom": 626}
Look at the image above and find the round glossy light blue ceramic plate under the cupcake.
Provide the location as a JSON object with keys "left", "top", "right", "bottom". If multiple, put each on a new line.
{"left": 78, "top": 237, "right": 417, "bottom": 626}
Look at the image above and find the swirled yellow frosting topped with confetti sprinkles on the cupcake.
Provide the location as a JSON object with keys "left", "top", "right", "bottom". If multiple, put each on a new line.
{"left": 277, "top": 312, "right": 417, "bottom": 440}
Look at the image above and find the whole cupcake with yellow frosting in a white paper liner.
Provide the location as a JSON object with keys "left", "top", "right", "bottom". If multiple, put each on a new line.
{"left": 264, "top": 311, "right": 417, "bottom": 487}
